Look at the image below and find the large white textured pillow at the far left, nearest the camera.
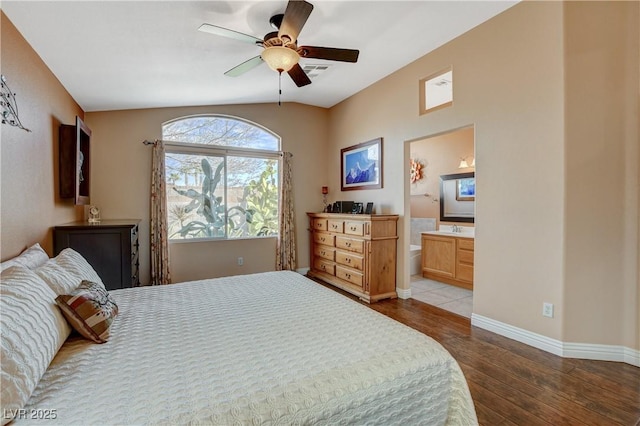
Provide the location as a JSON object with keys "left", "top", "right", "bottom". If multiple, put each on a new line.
{"left": 0, "top": 266, "right": 71, "bottom": 425}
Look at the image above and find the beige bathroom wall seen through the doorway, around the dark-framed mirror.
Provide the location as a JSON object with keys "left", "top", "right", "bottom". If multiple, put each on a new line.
{"left": 409, "top": 127, "right": 475, "bottom": 226}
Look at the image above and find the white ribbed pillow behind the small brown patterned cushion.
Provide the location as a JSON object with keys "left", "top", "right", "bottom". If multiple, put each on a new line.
{"left": 35, "top": 248, "right": 104, "bottom": 295}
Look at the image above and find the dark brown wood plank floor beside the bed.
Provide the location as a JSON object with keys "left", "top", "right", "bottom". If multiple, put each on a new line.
{"left": 316, "top": 286, "right": 640, "bottom": 426}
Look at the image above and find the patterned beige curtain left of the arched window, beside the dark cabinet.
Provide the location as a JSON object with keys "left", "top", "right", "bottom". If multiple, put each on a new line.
{"left": 151, "top": 140, "right": 171, "bottom": 285}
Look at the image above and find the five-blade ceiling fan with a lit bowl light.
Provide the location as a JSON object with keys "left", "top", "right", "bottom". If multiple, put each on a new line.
{"left": 198, "top": 0, "right": 360, "bottom": 87}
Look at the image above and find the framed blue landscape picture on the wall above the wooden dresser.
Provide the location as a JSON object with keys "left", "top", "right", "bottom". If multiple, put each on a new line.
{"left": 340, "top": 138, "right": 382, "bottom": 191}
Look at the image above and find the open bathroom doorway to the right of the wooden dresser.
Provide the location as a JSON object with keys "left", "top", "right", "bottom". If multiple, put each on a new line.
{"left": 405, "top": 126, "right": 475, "bottom": 318}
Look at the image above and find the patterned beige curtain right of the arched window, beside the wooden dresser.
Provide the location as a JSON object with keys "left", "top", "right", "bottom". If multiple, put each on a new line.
{"left": 276, "top": 152, "right": 296, "bottom": 271}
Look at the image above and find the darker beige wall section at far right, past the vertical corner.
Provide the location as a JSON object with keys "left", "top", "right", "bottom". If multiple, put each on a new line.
{"left": 564, "top": 2, "right": 640, "bottom": 348}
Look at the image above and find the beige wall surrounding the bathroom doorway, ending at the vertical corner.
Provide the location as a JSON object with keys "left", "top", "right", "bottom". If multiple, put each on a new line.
{"left": 329, "top": 2, "right": 564, "bottom": 338}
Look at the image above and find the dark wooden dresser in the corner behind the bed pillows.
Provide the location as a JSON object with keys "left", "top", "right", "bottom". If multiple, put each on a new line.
{"left": 53, "top": 219, "right": 140, "bottom": 290}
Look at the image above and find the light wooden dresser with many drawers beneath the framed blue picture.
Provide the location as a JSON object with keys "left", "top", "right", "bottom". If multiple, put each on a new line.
{"left": 307, "top": 213, "right": 398, "bottom": 303}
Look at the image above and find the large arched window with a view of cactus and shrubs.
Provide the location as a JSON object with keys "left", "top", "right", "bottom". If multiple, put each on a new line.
{"left": 162, "top": 115, "right": 280, "bottom": 240}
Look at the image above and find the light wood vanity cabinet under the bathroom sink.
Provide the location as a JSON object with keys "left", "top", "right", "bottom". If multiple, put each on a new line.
{"left": 422, "top": 232, "right": 474, "bottom": 290}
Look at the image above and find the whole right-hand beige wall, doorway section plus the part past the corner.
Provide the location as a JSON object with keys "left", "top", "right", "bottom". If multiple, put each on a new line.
{"left": 329, "top": 2, "right": 640, "bottom": 349}
